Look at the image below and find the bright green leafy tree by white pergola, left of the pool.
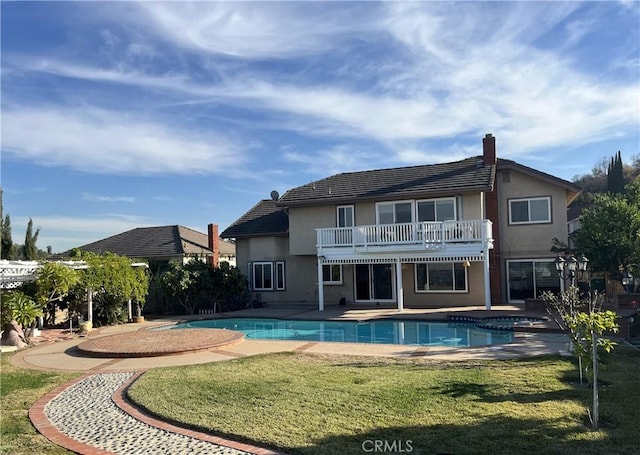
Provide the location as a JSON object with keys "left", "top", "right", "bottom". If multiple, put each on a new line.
{"left": 73, "top": 252, "right": 149, "bottom": 325}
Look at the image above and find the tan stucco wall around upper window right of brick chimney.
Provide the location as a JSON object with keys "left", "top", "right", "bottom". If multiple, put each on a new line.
{"left": 497, "top": 170, "right": 567, "bottom": 259}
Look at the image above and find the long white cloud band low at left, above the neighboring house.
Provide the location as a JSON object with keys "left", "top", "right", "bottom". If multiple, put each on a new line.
{"left": 2, "top": 108, "right": 246, "bottom": 175}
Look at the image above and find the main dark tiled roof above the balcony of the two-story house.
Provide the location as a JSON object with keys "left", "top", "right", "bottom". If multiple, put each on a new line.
{"left": 278, "top": 156, "right": 495, "bottom": 207}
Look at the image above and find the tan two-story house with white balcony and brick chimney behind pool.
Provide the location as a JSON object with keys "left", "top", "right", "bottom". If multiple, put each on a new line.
{"left": 221, "top": 134, "right": 579, "bottom": 311}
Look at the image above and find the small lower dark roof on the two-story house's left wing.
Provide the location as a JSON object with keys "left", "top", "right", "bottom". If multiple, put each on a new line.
{"left": 220, "top": 199, "right": 289, "bottom": 238}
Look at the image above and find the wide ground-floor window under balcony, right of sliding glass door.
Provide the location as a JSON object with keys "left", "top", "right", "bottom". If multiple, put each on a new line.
{"left": 415, "top": 262, "right": 467, "bottom": 292}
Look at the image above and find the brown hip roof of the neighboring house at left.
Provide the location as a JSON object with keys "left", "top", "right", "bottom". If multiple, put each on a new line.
{"left": 67, "top": 225, "right": 230, "bottom": 259}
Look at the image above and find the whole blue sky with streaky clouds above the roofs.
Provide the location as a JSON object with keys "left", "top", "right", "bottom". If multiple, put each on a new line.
{"left": 0, "top": 1, "right": 640, "bottom": 251}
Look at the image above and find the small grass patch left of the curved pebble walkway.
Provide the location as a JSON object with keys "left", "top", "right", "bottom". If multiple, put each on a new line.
{"left": 0, "top": 353, "right": 78, "bottom": 455}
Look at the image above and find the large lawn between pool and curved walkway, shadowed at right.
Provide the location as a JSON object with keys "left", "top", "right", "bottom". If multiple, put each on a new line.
{"left": 128, "top": 346, "right": 640, "bottom": 455}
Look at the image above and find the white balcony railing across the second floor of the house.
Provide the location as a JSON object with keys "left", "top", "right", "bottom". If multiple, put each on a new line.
{"left": 316, "top": 220, "right": 492, "bottom": 254}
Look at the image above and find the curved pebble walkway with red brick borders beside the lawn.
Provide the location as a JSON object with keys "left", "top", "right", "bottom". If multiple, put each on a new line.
{"left": 29, "top": 372, "right": 276, "bottom": 455}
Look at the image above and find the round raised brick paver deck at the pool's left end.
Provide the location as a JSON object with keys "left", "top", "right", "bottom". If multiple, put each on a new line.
{"left": 78, "top": 329, "right": 244, "bottom": 358}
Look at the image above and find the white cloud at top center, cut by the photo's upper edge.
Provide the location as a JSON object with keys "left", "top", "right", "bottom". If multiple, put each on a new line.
{"left": 134, "top": 2, "right": 376, "bottom": 59}
